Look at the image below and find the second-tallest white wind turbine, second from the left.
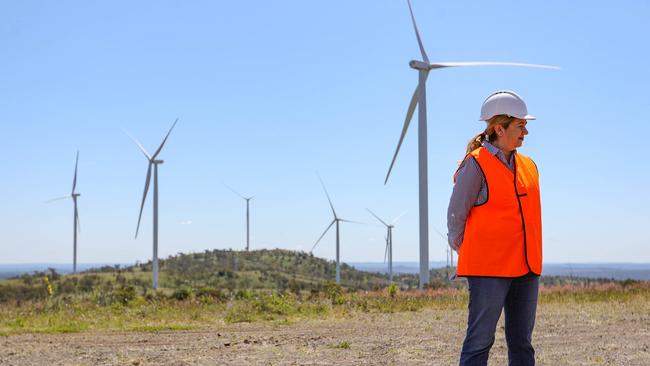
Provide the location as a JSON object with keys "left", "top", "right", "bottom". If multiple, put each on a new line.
{"left": 129, "top": 118, "right": 178, "bottom": 290}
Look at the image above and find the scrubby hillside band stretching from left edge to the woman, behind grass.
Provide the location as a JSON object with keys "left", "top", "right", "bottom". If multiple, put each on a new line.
{"left": 0, "top": 249, "right": 446, "bottom": 303}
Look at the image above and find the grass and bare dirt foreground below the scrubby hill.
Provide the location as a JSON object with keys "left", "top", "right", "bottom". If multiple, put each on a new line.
{"left": 0, "top": 282, "right": 650, "bottom": 365}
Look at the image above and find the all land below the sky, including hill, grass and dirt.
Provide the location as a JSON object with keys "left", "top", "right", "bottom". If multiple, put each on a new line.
{"left": 0, "top": 250, "right": 650, "bottom": 365}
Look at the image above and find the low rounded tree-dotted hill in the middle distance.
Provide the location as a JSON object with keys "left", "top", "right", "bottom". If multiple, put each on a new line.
{"left": 126, "top": 249, "right": 417, "bottom": 290}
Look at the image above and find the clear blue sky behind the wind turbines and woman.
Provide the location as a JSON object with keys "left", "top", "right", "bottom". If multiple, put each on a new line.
{"left": 0, "top": 0, "right": 650, "bottom": 263}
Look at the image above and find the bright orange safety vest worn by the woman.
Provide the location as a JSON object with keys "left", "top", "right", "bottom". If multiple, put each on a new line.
{"left": 457, "top": 147, "right": 542, "bottom": 277}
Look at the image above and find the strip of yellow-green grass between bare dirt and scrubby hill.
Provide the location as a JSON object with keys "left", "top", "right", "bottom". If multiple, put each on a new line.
{"left": 0, "top": 282, "right": 650, "bottom": 335}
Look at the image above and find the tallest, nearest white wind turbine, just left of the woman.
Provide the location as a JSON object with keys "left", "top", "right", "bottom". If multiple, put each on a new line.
{"left": 384, "top": 0, "right": 559, "bottom": 288}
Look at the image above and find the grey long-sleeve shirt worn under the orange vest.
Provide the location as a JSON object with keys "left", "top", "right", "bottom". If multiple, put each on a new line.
{"left": 447, "top": 141, "right": 517, "bottom": 251}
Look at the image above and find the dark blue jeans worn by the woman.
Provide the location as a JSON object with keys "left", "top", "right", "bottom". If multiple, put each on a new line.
{"left": 460, "top": 273, "right": 539, "bottom": 366}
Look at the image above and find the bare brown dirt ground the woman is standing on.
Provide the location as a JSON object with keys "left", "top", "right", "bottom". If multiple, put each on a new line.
{"left": 0, "top": 302, "right": 650, "bottom": 366}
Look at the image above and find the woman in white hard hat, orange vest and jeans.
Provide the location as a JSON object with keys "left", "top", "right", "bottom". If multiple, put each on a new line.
{"left": 447, "top": 90, "right": 542, "bottom": 365}
